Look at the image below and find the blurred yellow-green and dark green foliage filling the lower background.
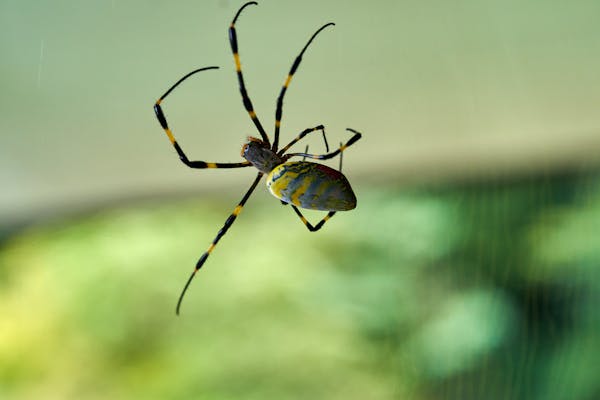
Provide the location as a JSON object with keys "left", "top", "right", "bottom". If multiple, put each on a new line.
{"left": 0, "top": 176, "right": 600, "bottom": 400}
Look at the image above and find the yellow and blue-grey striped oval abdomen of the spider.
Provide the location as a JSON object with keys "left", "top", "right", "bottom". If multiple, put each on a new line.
{"left": 267, "top": 161, "right": 356, "bottom": 211}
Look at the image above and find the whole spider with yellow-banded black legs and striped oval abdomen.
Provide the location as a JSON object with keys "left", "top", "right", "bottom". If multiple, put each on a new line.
{"left": 154, "top": 1, "right": 361, "bottom": 315}
